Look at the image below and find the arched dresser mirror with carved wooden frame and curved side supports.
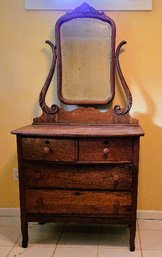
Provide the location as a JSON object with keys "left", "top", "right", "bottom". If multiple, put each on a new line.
{"left": 34, "top": 3, "right": 132, "bottom": 124}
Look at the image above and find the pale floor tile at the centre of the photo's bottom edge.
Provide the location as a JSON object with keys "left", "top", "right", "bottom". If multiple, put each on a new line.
{"left": 54, "top": 247, "right": 97, "bottom": 257}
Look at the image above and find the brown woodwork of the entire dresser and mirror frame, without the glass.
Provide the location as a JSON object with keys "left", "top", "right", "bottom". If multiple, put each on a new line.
{"left": 11, "top": 3, "right": 144, "bottom": 251}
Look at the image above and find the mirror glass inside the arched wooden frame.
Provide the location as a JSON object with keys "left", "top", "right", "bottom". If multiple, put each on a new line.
{"left": 60, "top": 18, "right": 112, "bottom": 104}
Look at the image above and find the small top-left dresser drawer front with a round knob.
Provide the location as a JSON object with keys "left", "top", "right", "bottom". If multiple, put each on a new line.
{"left": 22, "top": 138, "right": 76, "bottom": 162}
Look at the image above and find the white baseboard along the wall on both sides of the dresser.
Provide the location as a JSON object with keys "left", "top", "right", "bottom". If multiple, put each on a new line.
{"left": 0, "top": 208, "right": 162, "bottom": 220}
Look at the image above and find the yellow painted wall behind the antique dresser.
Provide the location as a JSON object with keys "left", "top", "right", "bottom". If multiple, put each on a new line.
{"left": 0, "top": 0, "right": 162, "bottom": 210}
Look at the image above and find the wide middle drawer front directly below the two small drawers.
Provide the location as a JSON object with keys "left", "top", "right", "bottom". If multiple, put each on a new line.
{"left": 23, "top": 163, "right": 132, "bottom": 190}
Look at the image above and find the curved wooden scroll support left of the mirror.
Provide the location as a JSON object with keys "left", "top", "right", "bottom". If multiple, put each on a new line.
{"left": 39, "top": 40, "right": 59, "bottom": 114}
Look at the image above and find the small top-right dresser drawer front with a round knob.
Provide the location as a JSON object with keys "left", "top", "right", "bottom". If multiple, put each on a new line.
{"left": 79, "top": 138, "right": 133, "bottom": 162}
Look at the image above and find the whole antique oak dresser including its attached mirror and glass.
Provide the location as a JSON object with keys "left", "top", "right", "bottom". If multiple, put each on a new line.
{"left": 12, "top": 3, "right": 144, "bottom": 251}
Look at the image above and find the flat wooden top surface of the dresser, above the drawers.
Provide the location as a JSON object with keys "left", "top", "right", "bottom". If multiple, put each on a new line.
{"left": 11, "top": 124, "right": 144, "bottom": 137}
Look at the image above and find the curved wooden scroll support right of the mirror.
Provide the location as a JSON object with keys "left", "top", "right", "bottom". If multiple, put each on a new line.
{"left": 114, "top": 41, "right": 132, "bottom": 115}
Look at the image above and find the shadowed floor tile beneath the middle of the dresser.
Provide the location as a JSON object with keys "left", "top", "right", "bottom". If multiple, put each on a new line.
{"left": 58, "top": 225, "right": 100, "bottom": 247}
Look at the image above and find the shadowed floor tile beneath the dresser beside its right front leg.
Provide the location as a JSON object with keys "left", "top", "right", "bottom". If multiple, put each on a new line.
{"left": 100, "top": 226, "right": 140, "bottom": 249}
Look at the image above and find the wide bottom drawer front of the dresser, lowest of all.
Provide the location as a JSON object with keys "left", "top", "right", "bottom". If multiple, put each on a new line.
{"left": 26, "top": 190, "right": 131, "bottom": 216}
